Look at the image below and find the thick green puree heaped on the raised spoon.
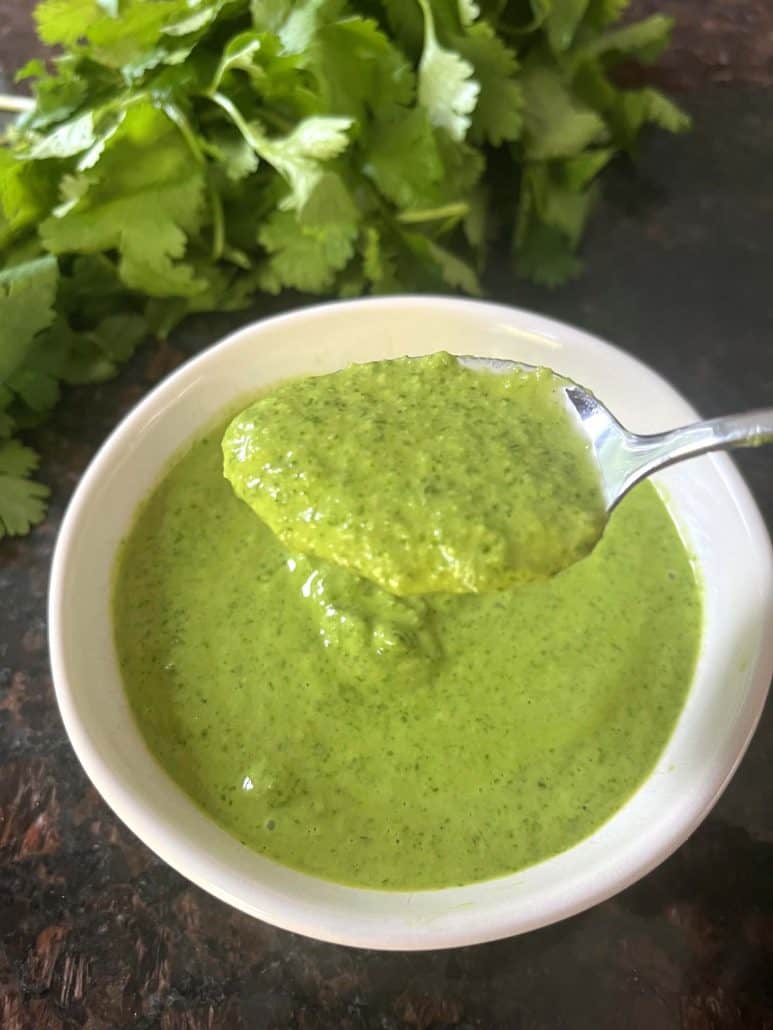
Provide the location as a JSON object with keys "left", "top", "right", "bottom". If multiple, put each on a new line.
{"left": 223, "top": 353, "right": 606, "bottom": 595}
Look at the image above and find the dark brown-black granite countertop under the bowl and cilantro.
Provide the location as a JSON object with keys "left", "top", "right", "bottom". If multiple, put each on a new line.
{"left": 0, "top": 0, "right": 773, "bottom": 1030}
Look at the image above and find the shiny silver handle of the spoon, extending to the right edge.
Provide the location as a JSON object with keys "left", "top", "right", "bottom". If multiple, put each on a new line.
{"left": 611, "top": 408, "right": 773, "bottom": 504}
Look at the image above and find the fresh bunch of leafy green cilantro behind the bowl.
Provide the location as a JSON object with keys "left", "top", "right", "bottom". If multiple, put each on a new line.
{"left": 0, "top": 0, "right": 686, "bottom": 537}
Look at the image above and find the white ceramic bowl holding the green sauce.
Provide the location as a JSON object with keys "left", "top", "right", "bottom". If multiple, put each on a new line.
{"left": 49, "top": 298, "right": 773, "bottom": 949}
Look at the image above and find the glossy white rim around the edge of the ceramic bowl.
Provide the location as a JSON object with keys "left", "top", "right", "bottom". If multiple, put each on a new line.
{"left": 48, "top": 295, "right": 773, "bottom": 950}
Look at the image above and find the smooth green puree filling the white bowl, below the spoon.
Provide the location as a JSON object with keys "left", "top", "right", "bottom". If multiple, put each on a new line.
{"left": 114, "top": 383, "right": 701, "bottom": 888}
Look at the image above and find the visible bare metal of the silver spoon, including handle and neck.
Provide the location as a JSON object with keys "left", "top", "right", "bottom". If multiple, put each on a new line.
{"left": 459, "top": 355, "right": 773, "bottom": 511}
